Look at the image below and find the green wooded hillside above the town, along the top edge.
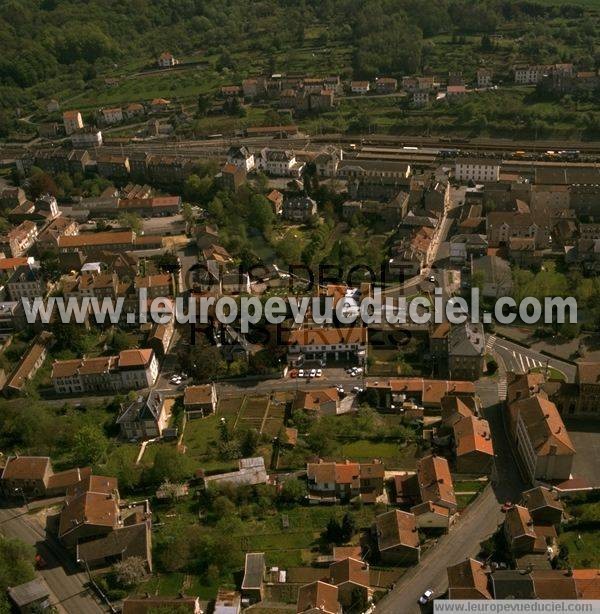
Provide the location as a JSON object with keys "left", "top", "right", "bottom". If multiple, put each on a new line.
{"left": 0, "top": 0, "right": 600, "bottom": 136}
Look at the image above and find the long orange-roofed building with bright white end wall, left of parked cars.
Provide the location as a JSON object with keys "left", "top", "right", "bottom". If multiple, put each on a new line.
{"left": 52, "top": 349, "right": 158, "bottom": 394}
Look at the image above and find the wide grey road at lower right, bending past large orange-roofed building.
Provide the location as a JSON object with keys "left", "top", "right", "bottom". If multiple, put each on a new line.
{"left": 375, "top": 382, "right": 526, "bottom": 614}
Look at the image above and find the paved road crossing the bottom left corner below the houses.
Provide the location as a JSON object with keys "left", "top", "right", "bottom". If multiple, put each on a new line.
{"left": 0, "top": 508, "right": 106, "bottom": 614}
